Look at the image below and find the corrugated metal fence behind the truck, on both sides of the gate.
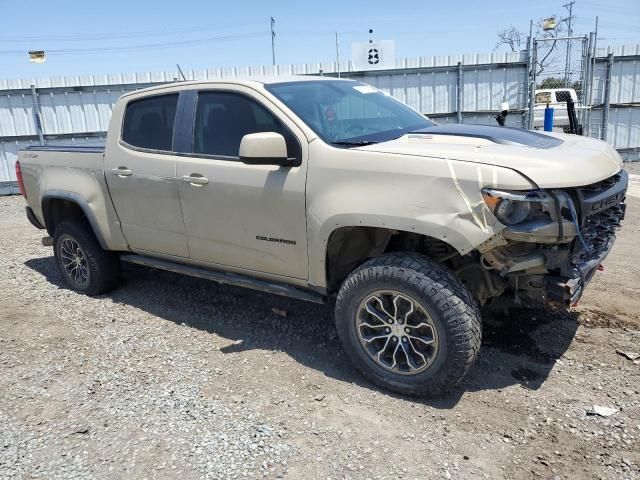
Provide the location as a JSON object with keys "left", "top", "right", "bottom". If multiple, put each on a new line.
{"left": 0, "top": 45, "right": 640, "bottom": 187}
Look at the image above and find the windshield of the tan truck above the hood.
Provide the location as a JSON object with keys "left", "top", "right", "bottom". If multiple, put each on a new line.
{"left": 266, "top": 80, "right": 435, "bottom": 146}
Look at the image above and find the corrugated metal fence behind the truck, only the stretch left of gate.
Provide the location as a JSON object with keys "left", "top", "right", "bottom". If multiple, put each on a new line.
{"left": 0, "top": 53, "right": 526, "bottom": 188}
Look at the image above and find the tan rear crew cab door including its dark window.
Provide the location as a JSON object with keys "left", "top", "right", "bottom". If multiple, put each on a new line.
{"left": 104, "top": 93, "right": 189, "bottom": 258}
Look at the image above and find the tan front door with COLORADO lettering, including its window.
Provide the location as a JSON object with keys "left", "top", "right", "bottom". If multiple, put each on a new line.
{"left": 172, "top": 86, "right": 308, "bottom": 279}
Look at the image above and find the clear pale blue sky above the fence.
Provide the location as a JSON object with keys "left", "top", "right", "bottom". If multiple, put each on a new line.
{"left": 0, "top": 0, "right": 640, "bottom": 78}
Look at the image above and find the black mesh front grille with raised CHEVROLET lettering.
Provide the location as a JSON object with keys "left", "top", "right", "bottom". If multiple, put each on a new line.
{"left": 572, "top": 170, "right": 628, "bottom": 264}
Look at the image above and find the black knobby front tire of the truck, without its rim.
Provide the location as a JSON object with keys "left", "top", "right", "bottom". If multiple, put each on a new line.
{"left": 335, "top": 253, "right": 482, "bottom": 397}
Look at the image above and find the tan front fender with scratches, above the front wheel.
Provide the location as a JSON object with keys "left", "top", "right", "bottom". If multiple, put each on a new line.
{"left": 307, "top": 145, "right": 535, "bottom": 287}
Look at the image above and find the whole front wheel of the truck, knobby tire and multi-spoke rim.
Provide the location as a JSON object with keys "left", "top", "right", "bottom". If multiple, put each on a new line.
{"left": 336, "top": 253, "right": 481, "bottom": 396}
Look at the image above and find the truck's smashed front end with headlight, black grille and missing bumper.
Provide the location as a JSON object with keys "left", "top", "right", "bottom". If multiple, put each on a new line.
{"left": 468, "top": 170, "right": 628, "bottom": 308}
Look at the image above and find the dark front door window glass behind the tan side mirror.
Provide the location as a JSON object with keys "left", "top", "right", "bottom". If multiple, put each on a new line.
{"left": 193, "top": 92, "right": 300, "bottom": 158}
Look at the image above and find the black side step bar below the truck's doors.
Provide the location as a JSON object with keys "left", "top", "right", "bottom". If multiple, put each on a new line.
{"left": 120, "top": 253, "right": 327, "bottom": 303}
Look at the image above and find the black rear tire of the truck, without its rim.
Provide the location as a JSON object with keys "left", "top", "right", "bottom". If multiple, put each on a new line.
{"left": 53, "top": 219, "right": 120, "bottom": 296}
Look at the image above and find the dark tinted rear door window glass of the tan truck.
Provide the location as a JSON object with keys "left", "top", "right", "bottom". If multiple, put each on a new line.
{"left": 122, "top": 94, "right": 178, "bottom": 151}
